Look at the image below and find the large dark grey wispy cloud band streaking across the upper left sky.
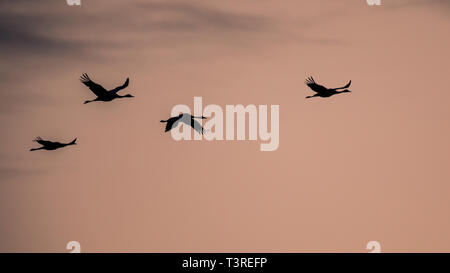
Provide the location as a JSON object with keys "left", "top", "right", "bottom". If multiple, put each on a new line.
{"left": 0, "top": 0, "right": 339, "bottom": 113}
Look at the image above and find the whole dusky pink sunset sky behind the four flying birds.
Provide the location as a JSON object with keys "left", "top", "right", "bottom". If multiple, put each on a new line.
{"left": 0, "top": 0, "right": 450, "bottom": 252}
